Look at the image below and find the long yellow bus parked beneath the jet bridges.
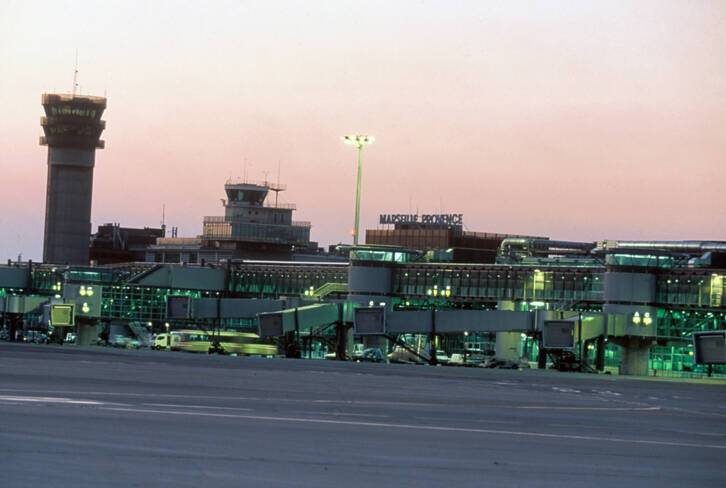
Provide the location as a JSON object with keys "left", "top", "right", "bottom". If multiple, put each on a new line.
{"left": 172, "top": 331, "right": 277, "bottom": 356}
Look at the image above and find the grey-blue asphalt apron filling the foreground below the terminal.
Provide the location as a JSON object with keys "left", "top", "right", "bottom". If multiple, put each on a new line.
{"left": 0, "top": 343, "right": 726, "bottom": 488}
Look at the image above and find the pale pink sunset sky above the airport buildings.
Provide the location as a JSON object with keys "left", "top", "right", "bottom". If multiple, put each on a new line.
{"left": 0, "top": 0, "right": 726, "bottom": 260}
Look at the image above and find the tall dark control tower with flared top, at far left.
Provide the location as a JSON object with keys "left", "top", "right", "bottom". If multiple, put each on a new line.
{"left": 40, "top": 94, "right": 106, "bottom": 264}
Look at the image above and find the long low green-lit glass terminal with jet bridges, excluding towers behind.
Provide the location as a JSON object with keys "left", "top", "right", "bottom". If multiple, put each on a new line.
{"left": 0, "top": 229, "right": 726, "bottom": 376}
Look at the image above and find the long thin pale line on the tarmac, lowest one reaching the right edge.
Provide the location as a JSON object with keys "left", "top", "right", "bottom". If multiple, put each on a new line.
{"left": 99, "top": 407, "right": 726, "bottom": 449}
